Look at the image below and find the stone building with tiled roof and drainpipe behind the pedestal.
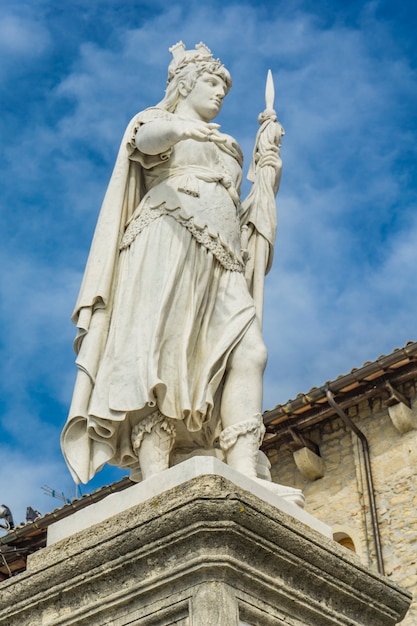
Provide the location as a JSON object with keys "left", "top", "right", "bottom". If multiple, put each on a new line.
{"left": 263, "top": 342, "right": 417, "bottom": 626}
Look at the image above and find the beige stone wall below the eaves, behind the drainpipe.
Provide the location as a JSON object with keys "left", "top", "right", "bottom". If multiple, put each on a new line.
{"left": 266, "top": 384, "right": 417, "bottom": 626}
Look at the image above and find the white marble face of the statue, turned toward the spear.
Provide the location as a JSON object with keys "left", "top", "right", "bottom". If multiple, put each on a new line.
{"left": 187, "top": 72, "right": 227, "bottom": 122}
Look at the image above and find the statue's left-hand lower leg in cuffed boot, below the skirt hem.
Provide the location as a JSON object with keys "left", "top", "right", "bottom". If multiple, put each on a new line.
{"left": 132, "top": 410, "right": 175, "bottom": 480}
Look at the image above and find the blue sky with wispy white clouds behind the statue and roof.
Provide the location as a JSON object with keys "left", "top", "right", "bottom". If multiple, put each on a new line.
{"left": 0, "top": 0, "right": 417, "bottom": 523}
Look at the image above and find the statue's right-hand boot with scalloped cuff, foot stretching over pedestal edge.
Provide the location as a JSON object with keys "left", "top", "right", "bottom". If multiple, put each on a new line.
{"left": 220, "top": 415, "right": 305, "bottom": 508}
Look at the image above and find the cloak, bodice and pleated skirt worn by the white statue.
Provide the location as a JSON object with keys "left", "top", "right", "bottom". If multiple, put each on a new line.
{"left": 61, "top": 110, "right": 255, "bottom": 482}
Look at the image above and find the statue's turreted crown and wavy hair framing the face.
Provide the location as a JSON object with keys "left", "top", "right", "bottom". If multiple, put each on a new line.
{"left": 158, "top": 41, "right": 232, "bottom": 112}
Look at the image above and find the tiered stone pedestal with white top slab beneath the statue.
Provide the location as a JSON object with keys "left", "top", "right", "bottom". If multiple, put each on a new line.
{"left": 0, "top": 457, "right": 410, "bottom": 626}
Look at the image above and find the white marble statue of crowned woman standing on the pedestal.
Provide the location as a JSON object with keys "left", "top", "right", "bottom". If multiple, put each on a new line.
{"left": 62, "top": 42, "right": 300, "bottom": 501}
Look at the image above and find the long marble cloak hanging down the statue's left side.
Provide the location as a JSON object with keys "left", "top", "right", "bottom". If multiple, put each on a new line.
{"left": 61, "top": 115, "right": 144, "bottom": 482}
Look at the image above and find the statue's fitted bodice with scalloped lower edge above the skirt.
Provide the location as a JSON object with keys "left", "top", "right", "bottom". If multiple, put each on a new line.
{"left": 121, "top": 109, "right": 244, "bottom": 272}
